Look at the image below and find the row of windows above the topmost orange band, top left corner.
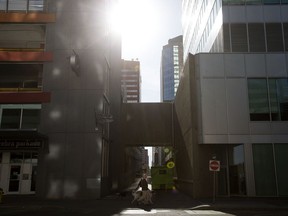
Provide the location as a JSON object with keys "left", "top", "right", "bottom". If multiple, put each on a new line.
{"left": 0, "top": 0, "right": 45, "bottom": 12}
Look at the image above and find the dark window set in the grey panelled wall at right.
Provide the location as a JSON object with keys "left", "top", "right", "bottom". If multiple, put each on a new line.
{"left": 248, "top": 78, "right": 288, "bottom": 121}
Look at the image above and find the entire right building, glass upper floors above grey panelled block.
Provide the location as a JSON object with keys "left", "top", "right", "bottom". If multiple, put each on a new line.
{"left": 175, "top": 0, "right": 288, "bottom": 197}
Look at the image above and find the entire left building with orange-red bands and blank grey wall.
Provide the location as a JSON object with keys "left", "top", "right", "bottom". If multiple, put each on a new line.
{"left": 0, "top": 0, "right": 121, "bottom": 199}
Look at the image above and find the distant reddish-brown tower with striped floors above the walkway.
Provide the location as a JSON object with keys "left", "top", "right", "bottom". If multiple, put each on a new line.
{"left": 121, "top": 60, "right": 141, "bottom": 103}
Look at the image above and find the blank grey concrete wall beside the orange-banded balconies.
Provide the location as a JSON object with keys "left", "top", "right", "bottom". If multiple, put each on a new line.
{"left": 37, "top": 0, "right": 121, "bottom": 198}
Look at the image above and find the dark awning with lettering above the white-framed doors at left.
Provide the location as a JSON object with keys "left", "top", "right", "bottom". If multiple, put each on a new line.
{"left": 0, "top": 130, "right": 48, "bottom": 150}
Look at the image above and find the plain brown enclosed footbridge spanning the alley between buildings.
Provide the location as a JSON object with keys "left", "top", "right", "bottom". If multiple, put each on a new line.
{"left": 121, "top": 103, "right": 174, "bottom": 147}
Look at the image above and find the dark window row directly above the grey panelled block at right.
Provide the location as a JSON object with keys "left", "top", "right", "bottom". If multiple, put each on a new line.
{"left": 223, "top": 23, "right": 288, "bottom": 52}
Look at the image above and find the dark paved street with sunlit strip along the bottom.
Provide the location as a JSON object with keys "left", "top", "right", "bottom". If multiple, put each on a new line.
{"left": 0, "top": 191, "right": 288, "bottom": 216}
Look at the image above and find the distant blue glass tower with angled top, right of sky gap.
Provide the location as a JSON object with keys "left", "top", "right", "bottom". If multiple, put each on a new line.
{"left": 160, "top": 35, "right": 183, "bottom": 102}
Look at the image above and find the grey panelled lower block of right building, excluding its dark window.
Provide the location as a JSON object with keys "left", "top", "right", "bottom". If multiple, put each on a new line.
{"left": 175, "top": 53, "right": 288, "bottom": 197}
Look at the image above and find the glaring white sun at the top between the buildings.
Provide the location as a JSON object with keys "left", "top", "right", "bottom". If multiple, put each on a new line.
{"left": 110, "top": 0, "right": 160, "bottom": 56}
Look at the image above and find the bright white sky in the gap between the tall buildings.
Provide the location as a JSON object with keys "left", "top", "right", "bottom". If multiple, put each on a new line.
{"left": 120, "top": 0, "right": 182, "bottom": 102}
